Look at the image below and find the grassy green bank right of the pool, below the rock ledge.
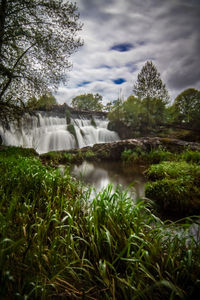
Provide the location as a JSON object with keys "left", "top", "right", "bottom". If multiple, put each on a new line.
{"left": 122, "top": 147, "right": 200, "bottom": 218}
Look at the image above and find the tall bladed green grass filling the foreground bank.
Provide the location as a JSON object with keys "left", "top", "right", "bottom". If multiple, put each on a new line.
{"left": 0, "top": 148, "right": 200, "bottom": 299}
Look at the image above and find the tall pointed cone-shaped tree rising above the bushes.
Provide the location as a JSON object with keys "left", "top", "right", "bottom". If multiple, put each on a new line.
{"left": 133, "top": 61, "right": 169, "bottom": 103}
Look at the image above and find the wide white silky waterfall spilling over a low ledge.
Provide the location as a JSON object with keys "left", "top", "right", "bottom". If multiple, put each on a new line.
{"left": 0, "top": 112, "right": 119, "bottom": 154}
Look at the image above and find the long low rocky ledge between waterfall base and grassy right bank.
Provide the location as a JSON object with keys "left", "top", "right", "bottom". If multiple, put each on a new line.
{"left": 40, "top": 137, "right": 200, "bottom": 163}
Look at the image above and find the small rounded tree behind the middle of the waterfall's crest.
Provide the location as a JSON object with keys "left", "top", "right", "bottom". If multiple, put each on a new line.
{"left": 72, "top": 94, "right": 103, "bottom": 111}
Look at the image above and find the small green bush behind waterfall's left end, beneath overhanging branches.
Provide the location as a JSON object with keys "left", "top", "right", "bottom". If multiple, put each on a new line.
{"left": 26, "top": 93, "right": 57, "bottom": 110}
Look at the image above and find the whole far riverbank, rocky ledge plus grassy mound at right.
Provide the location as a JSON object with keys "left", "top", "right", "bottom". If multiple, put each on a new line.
{"left": 40, "top": 137, "right": 200, "bottom": 219}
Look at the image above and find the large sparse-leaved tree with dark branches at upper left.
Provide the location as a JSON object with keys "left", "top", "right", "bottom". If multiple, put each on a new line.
{"left": 0, "top": 0, "right": 82, "bottom": 124}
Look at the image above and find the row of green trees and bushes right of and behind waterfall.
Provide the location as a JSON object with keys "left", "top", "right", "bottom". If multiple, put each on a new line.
{"left": 68, "top": 61, "right": 200, "bottom": 133}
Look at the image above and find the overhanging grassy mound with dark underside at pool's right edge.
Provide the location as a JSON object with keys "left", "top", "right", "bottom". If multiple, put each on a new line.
{"left": 145, "top": 161, "right": 200, "bottom": 216}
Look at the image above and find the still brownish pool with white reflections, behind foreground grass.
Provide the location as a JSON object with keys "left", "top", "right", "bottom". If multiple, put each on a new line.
{"left": 71, "top": 161, "right": 145, "bottom": 198}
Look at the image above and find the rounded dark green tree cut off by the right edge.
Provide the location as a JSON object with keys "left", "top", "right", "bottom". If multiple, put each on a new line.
{"left": 174, "top": 88, "right": 200, "bottom": 127}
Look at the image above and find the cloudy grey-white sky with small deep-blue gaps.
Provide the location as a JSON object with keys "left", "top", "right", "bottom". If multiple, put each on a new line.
{"left": 56, "top": 0, "right": 200, "bottom": 104}
